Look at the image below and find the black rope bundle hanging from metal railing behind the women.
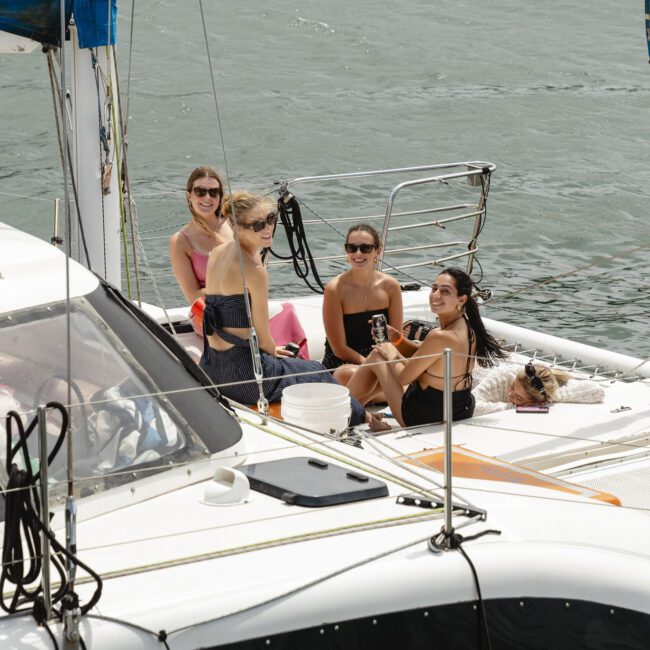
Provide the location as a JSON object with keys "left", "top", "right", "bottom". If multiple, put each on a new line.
{"left": 268, "top": 190, "right": 325, "bottom": 293}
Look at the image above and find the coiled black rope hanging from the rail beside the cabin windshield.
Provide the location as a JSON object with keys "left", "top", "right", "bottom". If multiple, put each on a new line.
{"left": 0, "top": 402, "right": 102, "bottom": 625}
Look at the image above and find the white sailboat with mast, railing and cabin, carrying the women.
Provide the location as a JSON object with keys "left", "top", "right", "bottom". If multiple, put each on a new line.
{"left": 0, "top": 2, "right": 650, "bottom": 650}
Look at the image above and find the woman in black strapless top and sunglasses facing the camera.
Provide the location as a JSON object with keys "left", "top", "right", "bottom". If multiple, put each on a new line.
{"left": 323, "top": 224, "right": 402, "bottom": 370}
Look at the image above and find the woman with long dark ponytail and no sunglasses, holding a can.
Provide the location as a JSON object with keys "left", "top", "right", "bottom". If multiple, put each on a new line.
{"left": 348, "top": 267, "right": 506, "bottom": 426}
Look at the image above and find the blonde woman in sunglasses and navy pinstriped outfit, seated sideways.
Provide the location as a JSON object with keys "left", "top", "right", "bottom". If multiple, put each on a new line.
{"left": 201, "top": 192, "right": 371, "bottom": 425}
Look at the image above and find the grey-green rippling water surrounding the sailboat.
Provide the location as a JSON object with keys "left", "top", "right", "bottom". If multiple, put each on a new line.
{"left": 0, "top": 0, "right": 650, "bottom": 357}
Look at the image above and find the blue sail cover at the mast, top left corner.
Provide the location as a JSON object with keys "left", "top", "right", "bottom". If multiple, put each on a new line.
{"left": 0, "top": 0, "right": 117, "bottom": 47}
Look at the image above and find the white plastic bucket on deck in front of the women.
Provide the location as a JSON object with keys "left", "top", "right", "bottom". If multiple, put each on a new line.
{"left": 280, "top": 383, "right": 352, "bottom": 433}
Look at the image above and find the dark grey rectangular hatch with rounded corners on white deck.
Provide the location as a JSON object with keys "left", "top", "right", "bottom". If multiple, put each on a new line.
{"left": 239, "top": 456, "right": 388, "bottom": 508}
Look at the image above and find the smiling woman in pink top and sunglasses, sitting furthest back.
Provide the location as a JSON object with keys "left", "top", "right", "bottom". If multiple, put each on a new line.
{"left": 169, "top": 167, "right": 233, "bottom": 305}
